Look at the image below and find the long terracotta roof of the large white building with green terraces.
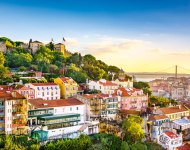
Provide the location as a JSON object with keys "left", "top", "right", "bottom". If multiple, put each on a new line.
{"left": 28, "top": 98, "right": 83, "bottom": 108}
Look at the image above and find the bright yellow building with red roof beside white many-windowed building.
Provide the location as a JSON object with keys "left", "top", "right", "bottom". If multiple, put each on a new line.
{"left": 54, "top": 77, "right": 78, "bottom": 98}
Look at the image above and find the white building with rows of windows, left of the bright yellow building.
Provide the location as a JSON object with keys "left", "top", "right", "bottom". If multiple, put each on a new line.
{"left": 25, "top": 83, "right": 60, "bottom": 100}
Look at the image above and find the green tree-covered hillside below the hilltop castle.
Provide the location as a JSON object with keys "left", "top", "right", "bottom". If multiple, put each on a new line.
{"left": 0, "top": 37, "right": 125, "bottom": 83}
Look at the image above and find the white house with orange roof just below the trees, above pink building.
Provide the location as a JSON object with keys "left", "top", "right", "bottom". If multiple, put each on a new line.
{"left": 88, "top": 79, "right": 119, "bottom": 94}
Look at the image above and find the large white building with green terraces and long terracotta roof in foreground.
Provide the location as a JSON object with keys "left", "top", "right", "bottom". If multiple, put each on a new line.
{"left": 28, "top": 98, "right": 99, "bottom": 140}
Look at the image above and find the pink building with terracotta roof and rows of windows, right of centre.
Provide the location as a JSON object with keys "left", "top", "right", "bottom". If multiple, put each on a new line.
{"left": 114, "top": 88, "right": 148, "bottom": 110}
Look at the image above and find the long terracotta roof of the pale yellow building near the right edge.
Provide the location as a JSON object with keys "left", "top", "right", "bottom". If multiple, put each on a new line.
{"left": 159, "top": 105, "right": 188, "bottom": 114}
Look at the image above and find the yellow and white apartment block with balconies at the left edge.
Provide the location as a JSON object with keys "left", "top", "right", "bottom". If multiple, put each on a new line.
{"left": 0, "top": 91, "right": 28, "bottom": 134}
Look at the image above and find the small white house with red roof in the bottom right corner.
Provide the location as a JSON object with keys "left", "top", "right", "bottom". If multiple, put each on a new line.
{"left": 158, "top": 132, "right": 183, "bottom": 150}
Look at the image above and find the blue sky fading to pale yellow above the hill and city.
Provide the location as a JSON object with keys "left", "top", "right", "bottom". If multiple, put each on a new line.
{"left": 0, "top": 0, "right": 190, "bottom": 72}
